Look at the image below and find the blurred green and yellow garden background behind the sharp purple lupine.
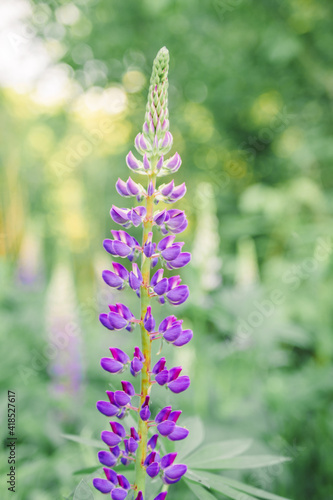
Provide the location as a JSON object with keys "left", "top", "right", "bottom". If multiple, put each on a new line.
{"left": 0, "top": 0, "right": 333, "bottom": 500}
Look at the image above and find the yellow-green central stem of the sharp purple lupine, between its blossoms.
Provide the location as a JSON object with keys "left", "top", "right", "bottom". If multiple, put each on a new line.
{"left": 134, "top": 164, "right": 157, "bottom": 495}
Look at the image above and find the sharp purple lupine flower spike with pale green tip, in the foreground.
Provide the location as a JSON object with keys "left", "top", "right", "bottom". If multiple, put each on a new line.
{"left": 93, "top": 47, "right": 193, "bottom": 500}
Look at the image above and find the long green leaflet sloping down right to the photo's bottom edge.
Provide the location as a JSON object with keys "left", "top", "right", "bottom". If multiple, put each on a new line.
{"left": 186, "top": 470, "right": 289, "bottom": 500}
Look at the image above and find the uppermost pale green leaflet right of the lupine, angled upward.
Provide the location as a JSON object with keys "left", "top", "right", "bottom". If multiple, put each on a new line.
{"left": 187, "top": 439, "right": 252, "bottom": 469}
